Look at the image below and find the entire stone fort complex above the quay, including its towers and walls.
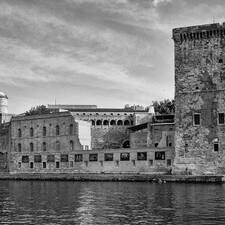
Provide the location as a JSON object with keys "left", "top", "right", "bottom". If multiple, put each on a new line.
{"left": 0, "top": 24, "right": 225, "bottom": 179}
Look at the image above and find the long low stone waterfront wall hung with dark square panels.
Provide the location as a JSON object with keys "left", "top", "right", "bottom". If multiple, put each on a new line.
{"left": 10, "top": 148, "right": 171, "bottom": 174}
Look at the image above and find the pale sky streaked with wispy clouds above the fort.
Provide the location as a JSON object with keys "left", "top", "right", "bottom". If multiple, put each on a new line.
{"left": 0, "top": 0, "right": 225, "bottom": 113}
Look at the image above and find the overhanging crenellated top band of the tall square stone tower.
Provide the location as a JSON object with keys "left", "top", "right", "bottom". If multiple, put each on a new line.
{"left": 173, "top": 22, "right": 225, "bottom": 43}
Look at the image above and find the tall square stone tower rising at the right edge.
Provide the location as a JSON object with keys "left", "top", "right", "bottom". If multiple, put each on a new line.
{"left": 173, "top": 23, "right": 225, "bottom": 174}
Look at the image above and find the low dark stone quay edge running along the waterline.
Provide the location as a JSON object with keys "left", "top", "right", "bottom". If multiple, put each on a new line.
{"left": 0, "top": 173, "right": 225, "bottom": 183}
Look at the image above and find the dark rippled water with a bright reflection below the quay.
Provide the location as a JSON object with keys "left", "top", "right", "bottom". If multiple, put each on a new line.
{"left": 0, "top": 181, "right": 225, "bottom": 225}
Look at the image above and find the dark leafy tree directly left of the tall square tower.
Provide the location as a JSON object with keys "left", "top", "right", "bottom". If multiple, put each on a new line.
{"left": 152, "top": 99, "right": 175, "bottom": 114}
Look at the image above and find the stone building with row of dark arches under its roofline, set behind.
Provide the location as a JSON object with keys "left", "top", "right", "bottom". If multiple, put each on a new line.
{"left": 48, "top": 105, "right": 151, "bottom": 150}
